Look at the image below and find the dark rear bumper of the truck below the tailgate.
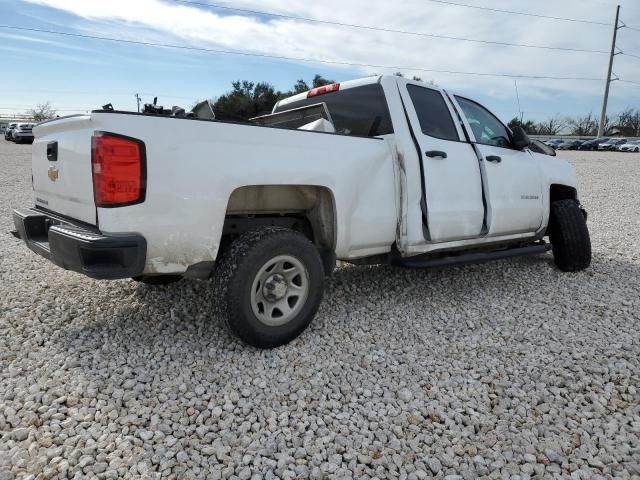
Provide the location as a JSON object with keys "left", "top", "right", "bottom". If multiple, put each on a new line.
{"left": 13, "top": 209, "right": 147, "bottom": 279}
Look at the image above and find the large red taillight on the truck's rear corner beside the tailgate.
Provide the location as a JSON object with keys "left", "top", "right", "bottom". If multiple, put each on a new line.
{"left": 91, "top": 133, "right": 146, "bottom": 207}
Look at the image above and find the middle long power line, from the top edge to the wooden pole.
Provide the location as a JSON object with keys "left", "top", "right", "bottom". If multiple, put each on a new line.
{"left": 173, "top": 0, "right": 609, "bottom": 53}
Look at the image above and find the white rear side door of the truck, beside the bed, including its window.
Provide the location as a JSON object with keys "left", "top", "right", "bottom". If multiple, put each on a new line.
{"left": 398, "top": 82, "right": 485, "bottom": 242}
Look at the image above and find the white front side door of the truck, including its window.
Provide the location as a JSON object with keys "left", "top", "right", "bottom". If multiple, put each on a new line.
{"left": 454, "top": 96, "right": 544, "bottom": 236}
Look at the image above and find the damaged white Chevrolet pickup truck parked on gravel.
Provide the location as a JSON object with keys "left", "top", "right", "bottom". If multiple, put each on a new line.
{"left": 13, "top": 76, "right": 591, "bottom": 348}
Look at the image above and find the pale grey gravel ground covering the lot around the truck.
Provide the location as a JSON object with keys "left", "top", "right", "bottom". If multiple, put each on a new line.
{"left": 0, "top": 141, "right": 640, "bottom": 480}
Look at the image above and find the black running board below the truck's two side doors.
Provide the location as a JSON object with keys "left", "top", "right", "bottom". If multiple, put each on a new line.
{"left": 393, "top": 242, "right": 551, "bottom": 268}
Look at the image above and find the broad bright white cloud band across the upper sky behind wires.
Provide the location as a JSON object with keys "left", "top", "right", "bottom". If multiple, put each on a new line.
{"left": 17, "top": 0, "right": 640, "bottom": 102}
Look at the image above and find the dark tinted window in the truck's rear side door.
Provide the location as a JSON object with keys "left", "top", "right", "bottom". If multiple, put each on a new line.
{"left": 407, "top": 85, "right": 460, "bottom": 141}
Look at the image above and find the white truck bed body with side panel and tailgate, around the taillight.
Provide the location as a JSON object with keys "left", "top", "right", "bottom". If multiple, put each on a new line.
{"left": 33, "top": 110, "right": 398, "bottom": 273}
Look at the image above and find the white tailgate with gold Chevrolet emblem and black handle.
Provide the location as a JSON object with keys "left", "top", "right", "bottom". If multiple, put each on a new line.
{"left": 32, "top": 115, "right": 96, "bottom": 225}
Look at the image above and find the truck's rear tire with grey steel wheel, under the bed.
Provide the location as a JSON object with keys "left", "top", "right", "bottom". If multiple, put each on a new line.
{"left": 214, "top": 227, "right": 324, "bottom": 348}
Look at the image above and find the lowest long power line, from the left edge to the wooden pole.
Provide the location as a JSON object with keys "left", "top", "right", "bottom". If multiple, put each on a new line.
{"left": 0, "top": 25, "right": 603, "bottom": 81}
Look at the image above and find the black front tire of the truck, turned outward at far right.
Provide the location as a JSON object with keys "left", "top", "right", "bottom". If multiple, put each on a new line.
{"left": 549, "top": 200, "right": 591, "bottom": 272}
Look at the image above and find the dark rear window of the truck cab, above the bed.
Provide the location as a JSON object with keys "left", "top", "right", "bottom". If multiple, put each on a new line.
{"left": 274, "top": 83, "right": 393, "bottom": 137}
